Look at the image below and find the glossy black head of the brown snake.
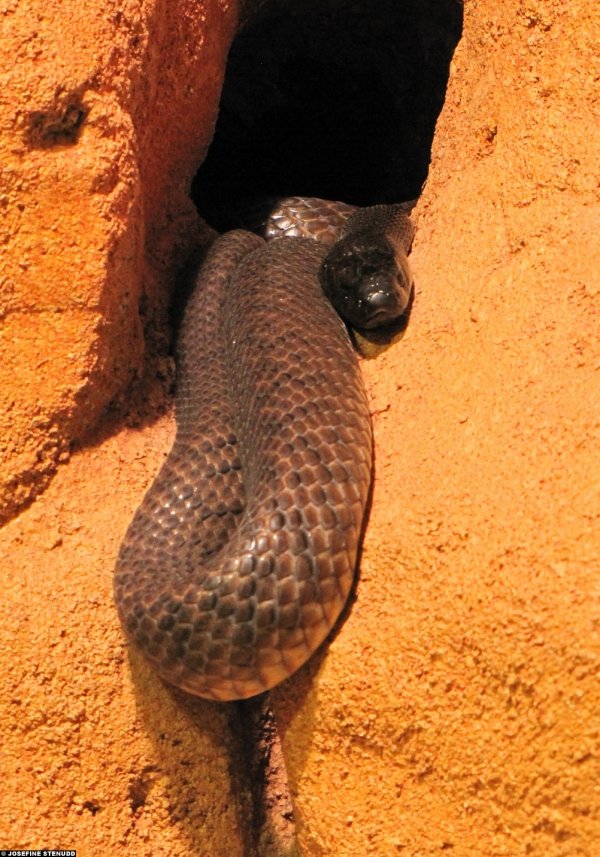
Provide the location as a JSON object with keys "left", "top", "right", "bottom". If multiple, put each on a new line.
{"left": 319, "top": 230, "right": 413, "bottom": 330}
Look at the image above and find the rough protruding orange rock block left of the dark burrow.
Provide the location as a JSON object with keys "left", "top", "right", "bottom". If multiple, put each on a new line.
{"left": 0, "top": 0, "right": 235, "bottom": 521}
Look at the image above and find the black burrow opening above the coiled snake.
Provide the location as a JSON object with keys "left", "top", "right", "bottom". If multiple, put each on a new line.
{"left": 192, "top": 0, "right": 463, "bottom": 231}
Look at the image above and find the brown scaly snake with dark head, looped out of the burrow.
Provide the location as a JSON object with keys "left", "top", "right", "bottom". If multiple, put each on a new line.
{"left": 115, "top": 198, "right": 413, "bottom": 700}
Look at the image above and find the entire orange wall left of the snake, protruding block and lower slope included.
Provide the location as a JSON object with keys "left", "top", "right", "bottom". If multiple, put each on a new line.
{"left": 0, "top": 0, "right": 249, "bottom": 857}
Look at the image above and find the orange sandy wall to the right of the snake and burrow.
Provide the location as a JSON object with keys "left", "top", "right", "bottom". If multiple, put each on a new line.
{"left": 276, "top": 0, "right": 600, "bottom": 857}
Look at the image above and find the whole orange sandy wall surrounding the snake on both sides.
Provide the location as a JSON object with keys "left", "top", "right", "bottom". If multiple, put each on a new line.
{"left": 0, "top": 0, "right": 600, "bottom": 857}
